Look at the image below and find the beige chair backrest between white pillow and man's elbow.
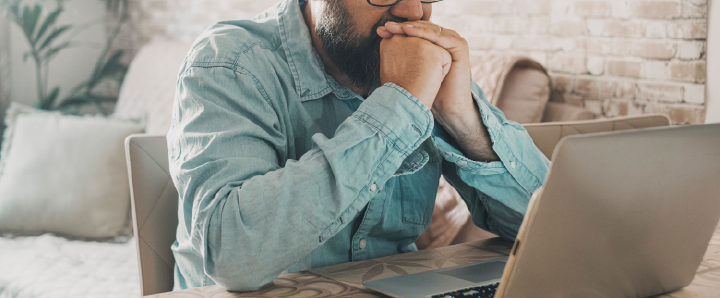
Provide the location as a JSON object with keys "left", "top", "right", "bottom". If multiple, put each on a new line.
{"left": 125, "top": 135, "right": 178, "bottom": 295}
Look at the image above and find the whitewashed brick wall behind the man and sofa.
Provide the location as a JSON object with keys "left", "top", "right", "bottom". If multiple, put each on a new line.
{"left": 128, "top": 0, "right": 707, "bottom": 124}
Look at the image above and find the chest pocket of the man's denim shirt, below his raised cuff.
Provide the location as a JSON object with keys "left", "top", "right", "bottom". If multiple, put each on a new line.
{"left": 398, "top": 140, "right": 441, "bottom": 225}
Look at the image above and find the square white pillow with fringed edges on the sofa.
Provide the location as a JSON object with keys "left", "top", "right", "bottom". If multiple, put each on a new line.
{"left": 0, "top": 103, "right": 143, "bottom": 237}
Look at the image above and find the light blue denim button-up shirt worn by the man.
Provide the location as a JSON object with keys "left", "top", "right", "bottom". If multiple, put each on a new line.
{"left": 168, "top": 0, "right": 549, "bottom": 291}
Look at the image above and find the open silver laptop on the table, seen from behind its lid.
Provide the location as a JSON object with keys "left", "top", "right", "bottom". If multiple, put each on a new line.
{"left": 363, "top": 124, "right": 720, "bottom": 298}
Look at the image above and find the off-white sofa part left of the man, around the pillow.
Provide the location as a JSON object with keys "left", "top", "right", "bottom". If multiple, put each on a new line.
{"left": 0, "top": 40, "right": 190, "bottom": 298}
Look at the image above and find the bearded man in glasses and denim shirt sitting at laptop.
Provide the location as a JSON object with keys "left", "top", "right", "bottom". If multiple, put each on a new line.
{"left": 168, "top": 0, "right": 549, "bottom": 291}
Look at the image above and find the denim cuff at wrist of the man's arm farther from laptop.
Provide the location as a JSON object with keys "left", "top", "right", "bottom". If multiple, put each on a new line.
{"left": 354, "top": 83, "right": 434, "bottom": 156}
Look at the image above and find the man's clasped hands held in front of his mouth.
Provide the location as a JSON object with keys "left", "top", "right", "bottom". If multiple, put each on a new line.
{"left": 377, "top": 21, "right": 477, "bottom": 122}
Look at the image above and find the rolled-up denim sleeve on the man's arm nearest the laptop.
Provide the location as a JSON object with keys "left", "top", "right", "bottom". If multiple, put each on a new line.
{"left": 432, "top": 84, "right": 550, "bottom": 240}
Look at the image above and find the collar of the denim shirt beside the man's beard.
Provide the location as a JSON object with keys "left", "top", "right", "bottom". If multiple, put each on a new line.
{"left": 278, "top": 0, "right": 354, "bottom": 101}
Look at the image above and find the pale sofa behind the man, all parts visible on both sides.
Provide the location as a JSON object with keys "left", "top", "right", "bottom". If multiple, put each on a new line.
{"left": 0, "top": 40, "right": 592, "bottom": 298}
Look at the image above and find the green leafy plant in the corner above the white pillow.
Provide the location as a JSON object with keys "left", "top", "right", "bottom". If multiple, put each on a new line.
{"left": 0, "top": 0, "right": 128, "bottom": 114}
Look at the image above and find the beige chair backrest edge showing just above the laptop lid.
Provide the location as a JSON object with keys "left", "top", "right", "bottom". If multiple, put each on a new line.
{"left": 523, "top": 114, "right": 670, "bottom": 158}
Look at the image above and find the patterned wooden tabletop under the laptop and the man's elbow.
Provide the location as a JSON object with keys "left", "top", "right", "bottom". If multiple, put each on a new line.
{"left": 146, "top": 226, "right": 720, "bottom": 298}
